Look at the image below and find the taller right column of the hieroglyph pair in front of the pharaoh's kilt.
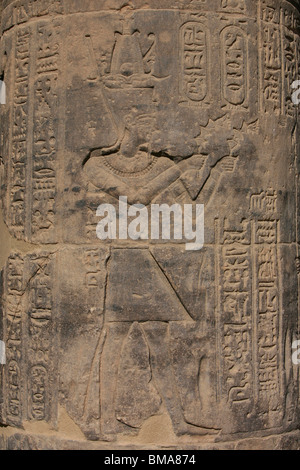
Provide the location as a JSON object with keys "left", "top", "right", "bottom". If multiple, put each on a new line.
{"left": 251, "top": 191, "right": 282, "bottom": 427}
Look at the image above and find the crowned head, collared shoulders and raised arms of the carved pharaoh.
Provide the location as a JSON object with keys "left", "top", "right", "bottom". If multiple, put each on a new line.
{"left": 84, "top": 13, "right": 237, "bottom": 205}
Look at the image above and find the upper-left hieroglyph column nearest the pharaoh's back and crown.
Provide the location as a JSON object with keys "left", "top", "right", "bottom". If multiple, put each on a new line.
{"left": 32, "top": 26, "right": 59, "bottom": 241}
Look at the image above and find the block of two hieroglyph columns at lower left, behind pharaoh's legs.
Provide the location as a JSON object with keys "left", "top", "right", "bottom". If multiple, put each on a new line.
{"left": 4, "top": 254, "right": 54, "bottom": 426}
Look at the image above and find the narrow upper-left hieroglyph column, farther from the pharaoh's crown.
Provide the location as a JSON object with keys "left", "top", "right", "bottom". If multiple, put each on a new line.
{"left": 10, "top": 29, "right": 30, "bottom": 234}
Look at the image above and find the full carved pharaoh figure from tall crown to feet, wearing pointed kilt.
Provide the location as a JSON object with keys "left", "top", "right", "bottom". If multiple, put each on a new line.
{"left": 84, "top": 13, "right": 239, "bottom": 436}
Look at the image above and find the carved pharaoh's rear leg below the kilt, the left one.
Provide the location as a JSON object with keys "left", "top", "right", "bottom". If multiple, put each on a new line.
{"left": 101, "top": 322, "right": 161, "bottom": 439}
